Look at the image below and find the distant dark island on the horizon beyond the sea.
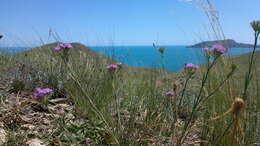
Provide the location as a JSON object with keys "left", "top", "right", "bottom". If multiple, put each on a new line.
{"left": 187, "top": 39, "right": 260, "bottom": 48}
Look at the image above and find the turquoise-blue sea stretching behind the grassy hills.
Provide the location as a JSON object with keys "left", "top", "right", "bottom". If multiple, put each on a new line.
{"left": 0, "top": 46, "right": 260, "bottom": 72}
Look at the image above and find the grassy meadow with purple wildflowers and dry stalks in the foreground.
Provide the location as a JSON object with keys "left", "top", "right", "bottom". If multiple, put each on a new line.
{"left": 0, "top": 1, "right": 260, "bottom": 146}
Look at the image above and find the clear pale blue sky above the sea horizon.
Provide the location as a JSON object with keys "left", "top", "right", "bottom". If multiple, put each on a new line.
{"left": 0, "top": 0, "right": 260, "bottom": 46}
